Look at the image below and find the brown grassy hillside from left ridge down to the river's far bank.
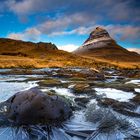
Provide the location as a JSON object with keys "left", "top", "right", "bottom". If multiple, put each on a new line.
{"left": 0, "top": 39, "right": 140, "bottom": 69}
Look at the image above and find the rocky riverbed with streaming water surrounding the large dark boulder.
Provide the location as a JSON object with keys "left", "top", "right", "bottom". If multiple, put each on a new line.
{"left": 0, "top": 68, "right": 140, "bottom": 140}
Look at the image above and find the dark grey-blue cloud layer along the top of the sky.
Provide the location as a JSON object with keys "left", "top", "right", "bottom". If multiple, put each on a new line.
{"left": 3, "top": 0, "right": 140, "bottom": 23}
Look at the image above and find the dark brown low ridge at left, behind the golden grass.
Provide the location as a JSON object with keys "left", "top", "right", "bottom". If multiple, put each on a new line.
{"left": 0, "top": 38, "right": 58, "bottom": 56}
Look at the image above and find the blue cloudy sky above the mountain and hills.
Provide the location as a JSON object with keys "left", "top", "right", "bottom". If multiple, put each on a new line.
{"left": 0, "top": 0, "right": 140, "bottom": 52}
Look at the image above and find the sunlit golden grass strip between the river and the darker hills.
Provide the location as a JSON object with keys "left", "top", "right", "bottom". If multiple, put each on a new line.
{"left": 0, "top": 51, "right": 140, "bottom": 69}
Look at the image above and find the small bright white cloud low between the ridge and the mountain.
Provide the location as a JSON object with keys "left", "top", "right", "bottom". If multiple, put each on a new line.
{"left": 57, "top": 44, "right": 79, "bottom": 52}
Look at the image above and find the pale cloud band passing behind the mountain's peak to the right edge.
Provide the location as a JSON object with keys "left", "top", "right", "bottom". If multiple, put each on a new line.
{"left": 47, "top": 24, "right": 140, "bottom": 43}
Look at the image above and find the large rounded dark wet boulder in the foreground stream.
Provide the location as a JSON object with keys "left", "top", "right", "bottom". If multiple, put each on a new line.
{"left": 2, "top": 88, "right": 72, "bottom": 125}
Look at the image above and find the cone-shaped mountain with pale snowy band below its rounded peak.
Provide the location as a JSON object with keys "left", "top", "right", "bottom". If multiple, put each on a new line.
{"left": 73, "top": 27, "right": 140, "bottom": 62}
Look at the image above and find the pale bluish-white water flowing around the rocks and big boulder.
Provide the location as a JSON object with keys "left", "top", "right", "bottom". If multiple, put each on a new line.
{"left": 0, "top": 69, "right": 140, "bottom": 140}
